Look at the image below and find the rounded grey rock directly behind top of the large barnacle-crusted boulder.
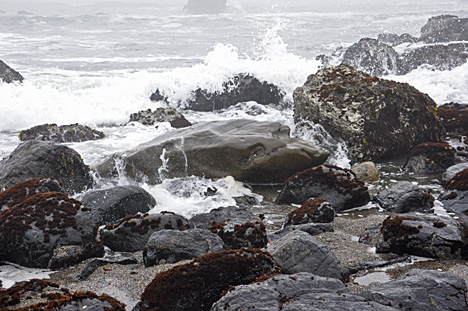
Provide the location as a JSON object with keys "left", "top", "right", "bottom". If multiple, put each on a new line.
{"left": 342, "top": 38, "right": 399, "bottom": 76}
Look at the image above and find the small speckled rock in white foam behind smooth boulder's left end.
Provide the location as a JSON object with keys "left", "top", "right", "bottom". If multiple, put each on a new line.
{"left": 130, "top": 108, "right": 192, "bottom": 128}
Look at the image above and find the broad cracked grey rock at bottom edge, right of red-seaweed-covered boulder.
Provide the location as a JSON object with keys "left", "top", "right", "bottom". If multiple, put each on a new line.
{"left": 211, "top": 273, "right": 397, "bottom": 311}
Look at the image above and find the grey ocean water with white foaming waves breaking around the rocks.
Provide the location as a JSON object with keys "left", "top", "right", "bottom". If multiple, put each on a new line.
{"left": 0, "top": 0, "right": 468, "bottom": 288}
